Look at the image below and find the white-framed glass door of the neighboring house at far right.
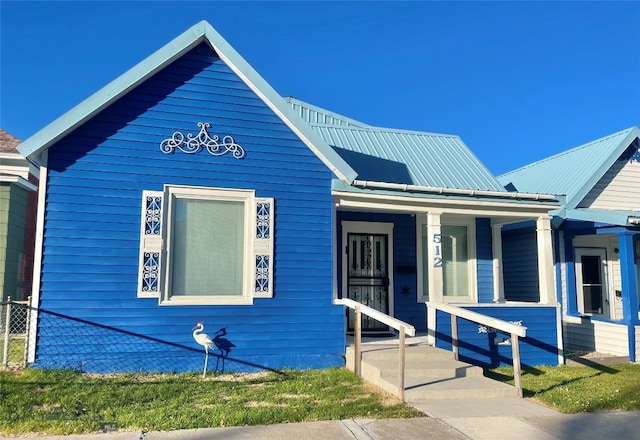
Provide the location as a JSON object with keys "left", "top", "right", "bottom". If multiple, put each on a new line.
{"left": 576, "top": 248, "right": 609, "bottom": 317}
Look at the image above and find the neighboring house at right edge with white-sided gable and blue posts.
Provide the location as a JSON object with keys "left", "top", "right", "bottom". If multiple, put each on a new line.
{"left": 500, "top": 127, "right": 640, "bottom": 362}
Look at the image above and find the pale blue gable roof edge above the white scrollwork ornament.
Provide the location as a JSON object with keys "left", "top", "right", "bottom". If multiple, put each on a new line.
{"left": 18, "top": 20, "right": 357, "bottom": 182}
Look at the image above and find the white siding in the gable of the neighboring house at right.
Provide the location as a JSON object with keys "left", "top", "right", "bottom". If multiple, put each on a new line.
{"left": 578, "top": 156, "right": 640, "bottom": 211}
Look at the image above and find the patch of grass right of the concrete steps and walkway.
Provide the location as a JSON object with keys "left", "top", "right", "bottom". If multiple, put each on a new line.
{"left": 485, "top": 364, "right": 640, "bottom": 414}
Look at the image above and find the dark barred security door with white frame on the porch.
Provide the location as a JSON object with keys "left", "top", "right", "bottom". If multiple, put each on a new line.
{"left": 343, "top": 222, "right": 393, "bottom": 333}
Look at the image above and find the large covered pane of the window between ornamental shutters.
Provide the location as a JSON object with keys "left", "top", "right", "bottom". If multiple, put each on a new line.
{"left": 170, "top": 197, "right": 244, "bottom": 296}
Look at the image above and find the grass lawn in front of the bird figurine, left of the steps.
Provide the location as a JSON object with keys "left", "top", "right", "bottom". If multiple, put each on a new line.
{"left": 0, "top": 369, "right": 421, "bottom": 434}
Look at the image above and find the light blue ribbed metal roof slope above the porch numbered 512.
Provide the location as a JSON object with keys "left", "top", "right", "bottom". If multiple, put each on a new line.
{"left": 311, "top": 124, "right": 506, "bottom": 192}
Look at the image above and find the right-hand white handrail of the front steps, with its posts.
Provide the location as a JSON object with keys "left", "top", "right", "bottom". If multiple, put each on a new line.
{"left": 426, "top": 301, "right": 527, "bottom": 397}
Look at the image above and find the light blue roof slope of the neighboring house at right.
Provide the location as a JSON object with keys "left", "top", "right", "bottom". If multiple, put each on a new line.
{"left": 498, "top": 127, "right": 640, "bottom": 209}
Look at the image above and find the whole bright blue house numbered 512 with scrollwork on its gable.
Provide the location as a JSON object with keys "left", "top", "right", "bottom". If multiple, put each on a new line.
{"left": 19, "top": 22, "right": 561, "bottom": 371}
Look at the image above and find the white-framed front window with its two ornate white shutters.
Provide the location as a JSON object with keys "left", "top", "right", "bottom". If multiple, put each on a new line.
{"left": 138, "top": 186, "right": 273, "bottom": 305}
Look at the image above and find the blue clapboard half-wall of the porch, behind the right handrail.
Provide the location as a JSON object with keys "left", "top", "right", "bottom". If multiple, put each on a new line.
{"left": 436, "top": 306, "right": 559, "bottom": 367}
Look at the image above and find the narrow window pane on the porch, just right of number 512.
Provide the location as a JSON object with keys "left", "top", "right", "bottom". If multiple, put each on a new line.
{"left": 441, "top": 225, "right": 469, "bottom": 296}
